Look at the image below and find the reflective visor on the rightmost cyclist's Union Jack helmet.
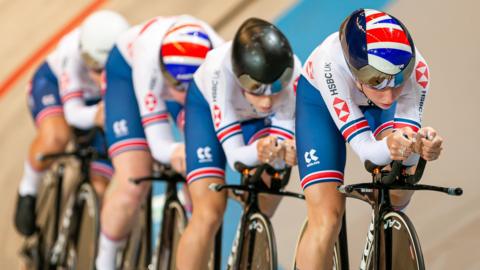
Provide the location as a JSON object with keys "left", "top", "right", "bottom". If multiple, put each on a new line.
{"left": 348, "top": 57, "right": 415, "bottom": 90}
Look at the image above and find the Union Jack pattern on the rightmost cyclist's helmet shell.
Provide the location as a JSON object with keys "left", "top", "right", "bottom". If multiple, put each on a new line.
{"left": 364, "top": 9, "right": 413, "bottom": 75}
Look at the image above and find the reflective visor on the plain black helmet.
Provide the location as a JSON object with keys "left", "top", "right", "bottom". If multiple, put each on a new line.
{"left": 238, "top": 67, "right": 293, "bottom": 96}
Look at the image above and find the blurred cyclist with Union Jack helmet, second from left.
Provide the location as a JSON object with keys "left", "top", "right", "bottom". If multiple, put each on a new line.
{"left": 96, "top": 15, "right": 223, "bottom": 269}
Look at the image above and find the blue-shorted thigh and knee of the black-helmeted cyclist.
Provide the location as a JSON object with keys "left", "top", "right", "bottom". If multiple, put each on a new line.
{"left": 185, "top": 83, "right": 226, "bottom": 209}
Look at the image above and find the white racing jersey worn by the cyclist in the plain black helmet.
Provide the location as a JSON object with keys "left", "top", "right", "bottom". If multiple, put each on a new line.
{"left": 194, "top": 42, "right": 301, "bottom": 168}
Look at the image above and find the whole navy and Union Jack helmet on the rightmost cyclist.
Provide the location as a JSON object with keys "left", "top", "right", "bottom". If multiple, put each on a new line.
{"left": 339, "top": 9, "right": 415, "bottom": 90}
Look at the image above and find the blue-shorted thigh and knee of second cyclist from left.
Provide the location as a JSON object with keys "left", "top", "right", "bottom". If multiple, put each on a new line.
{"left": 104, "top": 48, "right": 152, "bottom": 185}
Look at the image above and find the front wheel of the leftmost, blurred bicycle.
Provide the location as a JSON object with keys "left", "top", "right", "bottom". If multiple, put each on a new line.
{"left": 65, "top": 183, "right": 100, "bottom": 269}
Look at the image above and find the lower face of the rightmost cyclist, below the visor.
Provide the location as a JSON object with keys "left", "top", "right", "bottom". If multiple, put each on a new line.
{"left": 357, "top": 82, "right": 404, "bottom": 110}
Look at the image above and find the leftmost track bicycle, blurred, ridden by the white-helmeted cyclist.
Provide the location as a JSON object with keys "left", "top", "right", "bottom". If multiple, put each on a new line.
{"left": 22, "top": 128, "right": 106, "bottom": 269}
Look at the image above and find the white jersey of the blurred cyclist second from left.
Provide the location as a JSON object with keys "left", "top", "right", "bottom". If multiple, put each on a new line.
{"left": 116, "top": 15, "right": 223, "bottom": 163}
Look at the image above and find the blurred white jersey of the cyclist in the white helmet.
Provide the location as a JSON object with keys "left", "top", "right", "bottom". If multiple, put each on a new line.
{"left": 47, "top": 28, "right": 101, "bottom": 129}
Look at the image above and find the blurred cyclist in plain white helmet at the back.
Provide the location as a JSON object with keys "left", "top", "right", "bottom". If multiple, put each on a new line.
{"left": 15, "top": 10, "right": 129, "bottom": 236}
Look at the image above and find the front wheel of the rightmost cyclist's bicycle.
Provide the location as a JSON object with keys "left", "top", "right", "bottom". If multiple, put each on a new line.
{"left": 366, "top": 211, "right": 425, "bottom": 270}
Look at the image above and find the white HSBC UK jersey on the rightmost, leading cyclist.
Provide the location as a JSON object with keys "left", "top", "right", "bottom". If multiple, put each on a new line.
{"left": 298, "top": 32, "right": 429, "bottom": 165}
